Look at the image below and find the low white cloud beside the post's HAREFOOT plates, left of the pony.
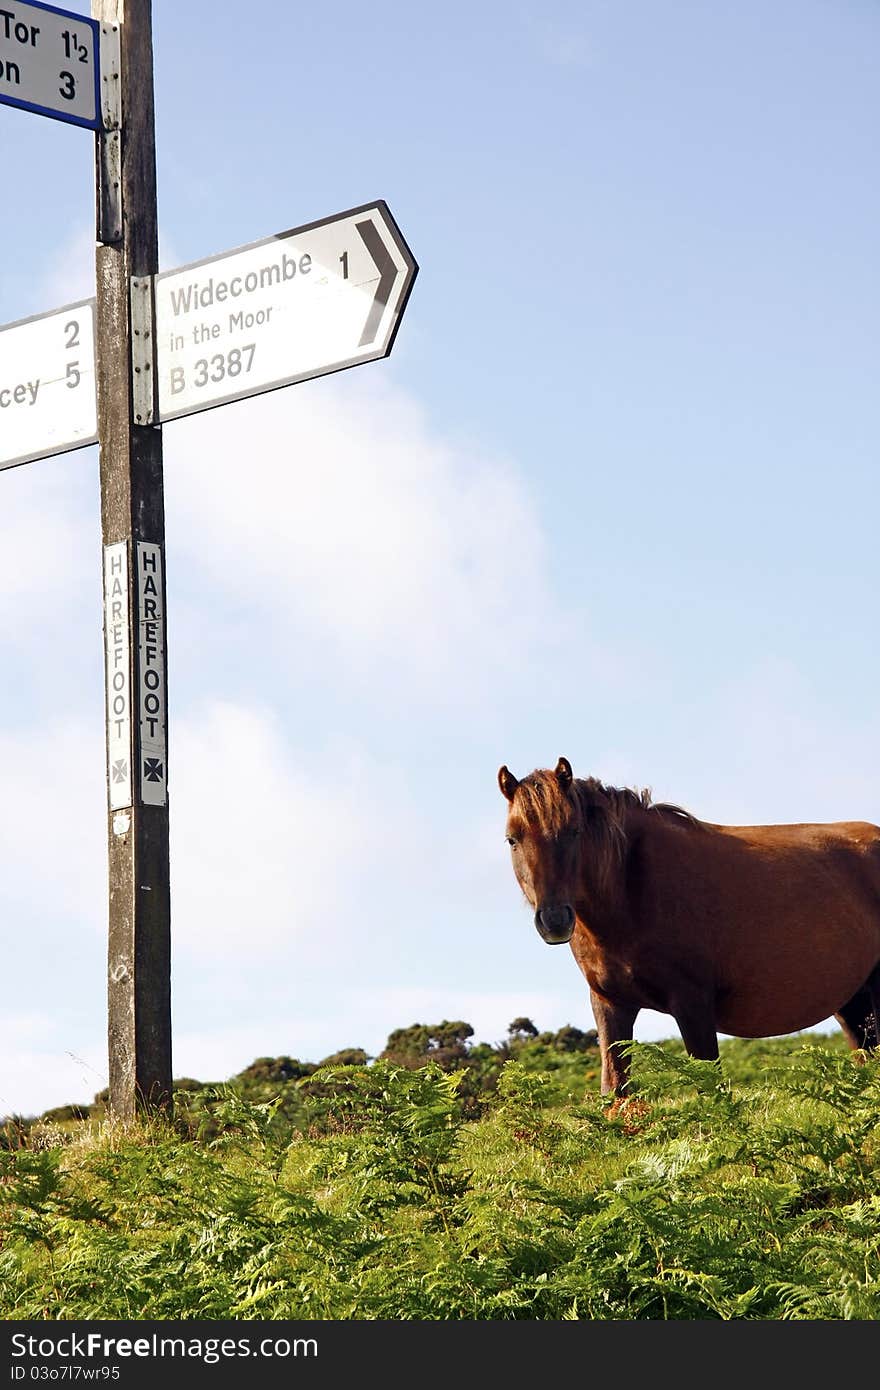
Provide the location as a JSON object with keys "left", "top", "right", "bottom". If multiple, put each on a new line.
{"left": 170, "top": 702, "right": 394, "bottom": 969}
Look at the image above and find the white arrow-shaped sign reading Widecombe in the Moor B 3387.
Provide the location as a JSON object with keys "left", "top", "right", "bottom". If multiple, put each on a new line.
{"left": 156, "top": 202, "right": 418, "bottom": 420}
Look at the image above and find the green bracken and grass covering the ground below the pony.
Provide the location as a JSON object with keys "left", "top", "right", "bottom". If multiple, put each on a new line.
{"left": 0, "top": 1036, "right": 880, "bottom": 1321}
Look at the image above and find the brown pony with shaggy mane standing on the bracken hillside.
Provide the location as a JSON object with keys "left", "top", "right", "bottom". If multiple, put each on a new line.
{"left": 498, "top": 758, "right": 880, "bottom": 1095}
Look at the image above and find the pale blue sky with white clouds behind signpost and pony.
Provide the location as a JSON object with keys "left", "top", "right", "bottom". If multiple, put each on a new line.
{"left": 0, "top": 0, "right": 880, "bottom": 1113}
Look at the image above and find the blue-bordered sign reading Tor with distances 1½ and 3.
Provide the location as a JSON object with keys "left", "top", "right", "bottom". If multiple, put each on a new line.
{"left": 0, "top": 0, "right": 101, "bottom": 131}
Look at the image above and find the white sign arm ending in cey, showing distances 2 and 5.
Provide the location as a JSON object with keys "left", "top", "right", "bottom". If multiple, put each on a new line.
{"left": 0, "top": 298, "right": 97, "bottom": 468}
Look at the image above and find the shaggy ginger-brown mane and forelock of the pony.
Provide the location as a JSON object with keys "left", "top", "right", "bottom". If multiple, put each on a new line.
{"left": 512, "top": 769, "right": 708, "bottom": 885}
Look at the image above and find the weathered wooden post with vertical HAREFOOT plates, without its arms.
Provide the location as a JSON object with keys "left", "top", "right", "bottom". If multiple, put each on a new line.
{"left": 92, "top": 0, "right": 171, "bottom": 1120}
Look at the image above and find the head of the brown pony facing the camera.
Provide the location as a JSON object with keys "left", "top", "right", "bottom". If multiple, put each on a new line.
{"left": 498, "top": 758, "right": 584, "bottom": 945}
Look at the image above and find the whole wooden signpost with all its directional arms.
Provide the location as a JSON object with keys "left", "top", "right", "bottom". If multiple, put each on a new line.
{"left": 0, "top": 0, "right": 418, "bottom": 1119}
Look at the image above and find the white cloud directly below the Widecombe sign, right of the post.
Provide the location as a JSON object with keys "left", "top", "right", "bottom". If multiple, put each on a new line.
{"left": 165, "top": 368, "right": 557, "bottom": 706}
